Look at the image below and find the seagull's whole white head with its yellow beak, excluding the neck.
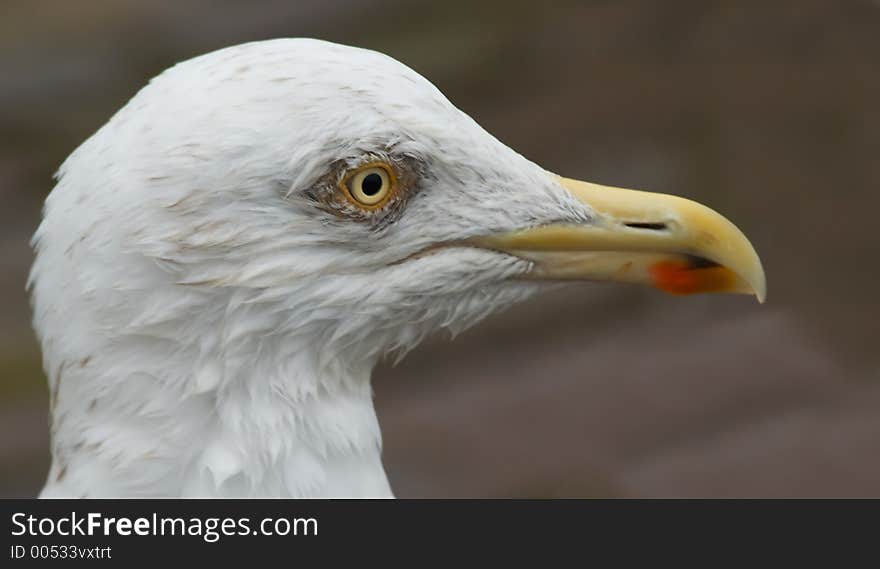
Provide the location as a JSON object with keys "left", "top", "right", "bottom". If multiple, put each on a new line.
{"left": 35, "top": 40, "right": 765, "bottom": 368}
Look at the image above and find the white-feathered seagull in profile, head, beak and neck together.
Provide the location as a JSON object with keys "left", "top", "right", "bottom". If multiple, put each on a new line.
{"left": 28, "top": 38, "right": 766, "bottom": 498}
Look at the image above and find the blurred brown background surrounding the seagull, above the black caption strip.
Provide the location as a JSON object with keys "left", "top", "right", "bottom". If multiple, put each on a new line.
{"left": 0, "top": 0, "right": 880, "bottom": 497}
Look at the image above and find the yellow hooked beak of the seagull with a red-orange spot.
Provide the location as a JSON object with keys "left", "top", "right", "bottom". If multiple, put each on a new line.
{"left": 474, "top": 178, "right": 767, "bottom": 302}
